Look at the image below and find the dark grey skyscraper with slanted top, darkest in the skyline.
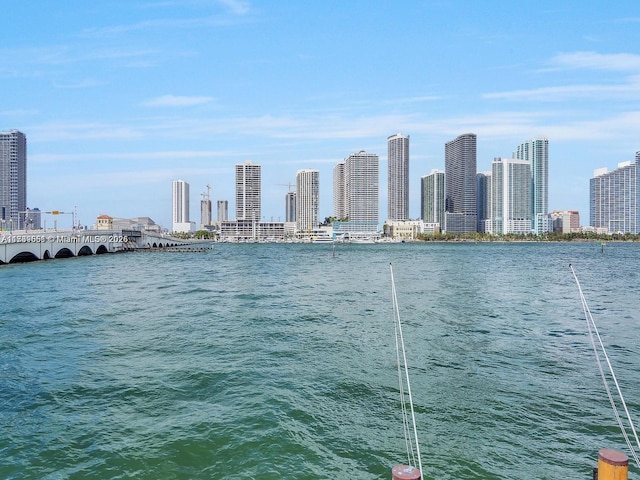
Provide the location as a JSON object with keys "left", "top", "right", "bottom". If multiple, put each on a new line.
{"left": 444, "top": 133, "right": 478, "bottom": 233}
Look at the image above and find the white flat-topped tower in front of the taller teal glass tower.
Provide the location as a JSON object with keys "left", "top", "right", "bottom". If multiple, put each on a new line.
{"left": 489, "top": 158, "right": 531, "bottom": 235}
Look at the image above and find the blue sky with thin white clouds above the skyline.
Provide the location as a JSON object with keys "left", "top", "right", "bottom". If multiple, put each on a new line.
{"left": 0, "top": 0, "right": 640, "bottom": 228}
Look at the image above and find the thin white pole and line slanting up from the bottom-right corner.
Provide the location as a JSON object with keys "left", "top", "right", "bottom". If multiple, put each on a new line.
{"left": 569, "top": 264, "right": 640, "bottom": 468}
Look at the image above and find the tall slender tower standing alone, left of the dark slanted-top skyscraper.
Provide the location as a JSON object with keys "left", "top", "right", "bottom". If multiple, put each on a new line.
{"left": 387, "top": 133, "right": 409, "bottom": 220}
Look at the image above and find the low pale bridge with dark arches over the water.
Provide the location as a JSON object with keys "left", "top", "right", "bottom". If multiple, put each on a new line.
{"left": 0, "top": 230, "right": 190, "bottom": 264}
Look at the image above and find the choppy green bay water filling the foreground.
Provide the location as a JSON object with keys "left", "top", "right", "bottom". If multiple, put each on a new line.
{"left": 0, "top": 243, "right": 640, "bottom": 480}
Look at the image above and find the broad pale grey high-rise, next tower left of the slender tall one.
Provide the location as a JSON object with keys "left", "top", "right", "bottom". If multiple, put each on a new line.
{"left": 344, "top": 151, "right": 379, "bottom": 233}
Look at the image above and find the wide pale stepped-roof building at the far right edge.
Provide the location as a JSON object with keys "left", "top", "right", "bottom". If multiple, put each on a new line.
{"left": 589, "top": 159, "right": 640, "bottom": 233}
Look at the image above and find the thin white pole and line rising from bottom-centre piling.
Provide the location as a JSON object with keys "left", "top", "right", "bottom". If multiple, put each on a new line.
{"left": 389, "top": 264, "right": 422, "bottom": 473}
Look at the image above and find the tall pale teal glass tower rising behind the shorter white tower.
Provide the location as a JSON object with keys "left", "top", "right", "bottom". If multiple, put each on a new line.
{"left": 515, "top": 136, "right": 549, "bottom": 235}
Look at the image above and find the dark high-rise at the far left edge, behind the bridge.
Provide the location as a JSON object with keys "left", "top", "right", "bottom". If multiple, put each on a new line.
{"left": 0, "top": 130, "right": 27, "bottom": 229}
